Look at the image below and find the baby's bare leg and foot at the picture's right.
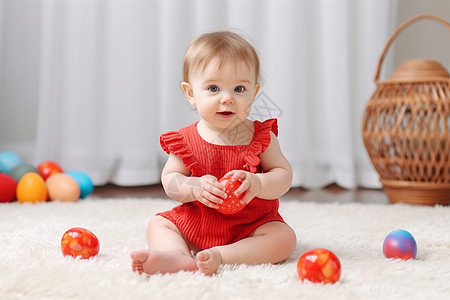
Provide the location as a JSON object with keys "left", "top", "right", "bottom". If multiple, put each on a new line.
{"left": 197, "top": 222, "right": 297, "bottom": 275}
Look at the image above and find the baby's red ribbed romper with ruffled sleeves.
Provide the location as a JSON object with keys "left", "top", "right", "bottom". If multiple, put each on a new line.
{"left": 158, "top": 119, "right": 284, "bottom": 249}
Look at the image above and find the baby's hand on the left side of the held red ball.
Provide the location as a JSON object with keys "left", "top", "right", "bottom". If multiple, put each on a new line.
{"left": 195, "top": 175, "right": 227, "bottom": 209}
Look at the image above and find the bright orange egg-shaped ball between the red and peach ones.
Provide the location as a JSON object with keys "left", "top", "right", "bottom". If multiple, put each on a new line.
{"left": 16, "top": 172, "right": 48, "bottom": 203}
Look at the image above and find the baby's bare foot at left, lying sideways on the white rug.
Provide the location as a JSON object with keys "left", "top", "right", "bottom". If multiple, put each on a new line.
{"left": 130, "top": 250, "right": 197, "bottom": 275}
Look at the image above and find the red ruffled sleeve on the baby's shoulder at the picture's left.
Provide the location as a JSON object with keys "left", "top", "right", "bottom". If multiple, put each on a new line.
{"left": 159, "top": 131, "right": 198, "bottom": 172}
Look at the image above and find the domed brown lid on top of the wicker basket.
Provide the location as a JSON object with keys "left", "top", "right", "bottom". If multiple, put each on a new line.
{"left": 385, "top": 59, "right": 450, "bottom": 83}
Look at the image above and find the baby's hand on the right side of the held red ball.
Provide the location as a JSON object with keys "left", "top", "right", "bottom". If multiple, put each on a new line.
{"left": 223, "top": 170, "right": 261, "bottom": 205}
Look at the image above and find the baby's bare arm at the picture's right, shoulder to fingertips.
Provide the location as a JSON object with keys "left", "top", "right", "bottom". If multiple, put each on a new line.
{"left": 226, "top": 132, "right": 292, "bottom": 203}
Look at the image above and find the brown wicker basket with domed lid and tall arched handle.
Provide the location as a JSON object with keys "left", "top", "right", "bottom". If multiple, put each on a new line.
{"left": 362, "top": 15, "right": 450, "bottom": 205}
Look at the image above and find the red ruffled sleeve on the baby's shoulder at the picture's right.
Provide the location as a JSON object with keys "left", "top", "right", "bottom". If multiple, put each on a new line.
{"left": 244, "top": 119, "right": 278, "bottom": 173}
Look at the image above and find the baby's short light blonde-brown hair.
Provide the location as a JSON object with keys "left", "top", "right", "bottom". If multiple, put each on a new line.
{"left": 183, "top": 31, "right": 260, "bottom": 82}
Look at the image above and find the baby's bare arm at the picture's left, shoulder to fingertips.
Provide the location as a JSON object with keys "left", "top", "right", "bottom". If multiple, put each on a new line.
{"left": 161, "top": 154, "right": 227, "bottom": 208}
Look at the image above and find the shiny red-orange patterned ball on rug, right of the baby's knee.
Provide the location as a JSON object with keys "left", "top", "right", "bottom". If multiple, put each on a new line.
{"left": 297, "top": 248, "right": 341, "bottom": 283}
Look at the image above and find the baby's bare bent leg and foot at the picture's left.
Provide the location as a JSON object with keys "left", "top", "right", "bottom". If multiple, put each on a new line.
{"left": 130, "top": 216, "right": 197, "bottom": 274}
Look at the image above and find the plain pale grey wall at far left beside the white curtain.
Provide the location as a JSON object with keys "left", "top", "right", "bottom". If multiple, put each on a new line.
{"left": 0, "top": 0, "right": 40, "bottom": 160}
